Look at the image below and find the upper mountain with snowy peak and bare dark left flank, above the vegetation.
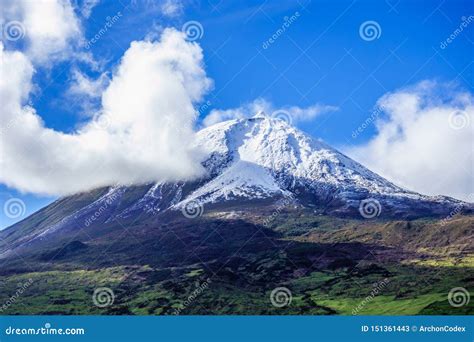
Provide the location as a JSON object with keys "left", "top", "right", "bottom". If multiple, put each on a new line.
{"left": 0, "top": 113, "right": 473, "bottom": 258}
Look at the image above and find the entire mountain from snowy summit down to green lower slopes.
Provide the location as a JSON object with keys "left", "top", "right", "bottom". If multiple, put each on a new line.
{"left": 0, "top": 114, "right": 474, "bottom": 314}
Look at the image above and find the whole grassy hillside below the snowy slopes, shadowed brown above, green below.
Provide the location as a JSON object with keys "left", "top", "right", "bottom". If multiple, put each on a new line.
{"left": 0, "top": 209, "right": 474, "bottom": 315}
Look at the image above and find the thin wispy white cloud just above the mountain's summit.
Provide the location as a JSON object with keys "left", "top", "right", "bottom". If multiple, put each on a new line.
{"left": 203, "top": 98, "right": 338, "bottom": 126}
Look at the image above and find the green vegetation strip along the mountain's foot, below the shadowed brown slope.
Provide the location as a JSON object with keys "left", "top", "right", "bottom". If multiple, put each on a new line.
{"left": 0, "top": 260, "right": 474, "bottom": 315}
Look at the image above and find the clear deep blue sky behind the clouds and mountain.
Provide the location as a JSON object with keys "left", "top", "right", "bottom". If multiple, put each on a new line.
{"left": 0, "top": 0, "right": 474, "bottom": 227}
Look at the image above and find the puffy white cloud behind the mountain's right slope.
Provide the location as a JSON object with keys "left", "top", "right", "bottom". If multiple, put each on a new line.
{"left": 346, "top": 81, "right": 474, "bottom": 201}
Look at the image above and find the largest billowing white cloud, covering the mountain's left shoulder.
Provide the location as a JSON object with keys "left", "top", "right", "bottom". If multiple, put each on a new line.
{"left": 0, "top": 29, "right": 211, "bottom": 194}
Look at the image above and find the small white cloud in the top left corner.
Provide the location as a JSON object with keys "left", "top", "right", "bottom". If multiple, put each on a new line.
{"left": 0, "top": 0, "right": 82, "bottom": 64}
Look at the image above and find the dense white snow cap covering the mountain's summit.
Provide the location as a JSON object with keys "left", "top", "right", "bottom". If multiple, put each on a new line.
{"left": 175, "top": 113, "right": 421, "bottom": 208}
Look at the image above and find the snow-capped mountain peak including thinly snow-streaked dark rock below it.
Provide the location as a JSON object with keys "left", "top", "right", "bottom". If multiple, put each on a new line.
{"left": 65, "top": 112, "right": 464, "bottom": 218}
